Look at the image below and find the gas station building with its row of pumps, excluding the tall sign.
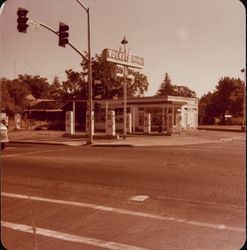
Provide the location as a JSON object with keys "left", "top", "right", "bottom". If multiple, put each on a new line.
{"left": 66, "top": 96, "right": 198, "bottom": 136}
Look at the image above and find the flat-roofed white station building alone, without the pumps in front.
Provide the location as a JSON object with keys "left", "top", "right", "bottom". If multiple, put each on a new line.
{"left": 94, "top": 96, "right": 198, "bottom": 133}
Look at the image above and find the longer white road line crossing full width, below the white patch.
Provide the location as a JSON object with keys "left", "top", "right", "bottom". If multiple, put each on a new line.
{"left": 2, "top": 192, "right": 245, "bottom": 233}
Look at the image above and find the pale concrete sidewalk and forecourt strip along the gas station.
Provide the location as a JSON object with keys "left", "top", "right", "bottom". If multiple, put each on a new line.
{"left": 9, "top": 130, "right": 245, "bottom": 147}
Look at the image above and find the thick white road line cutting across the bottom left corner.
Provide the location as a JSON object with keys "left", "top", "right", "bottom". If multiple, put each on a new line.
{"left": 1, "top": 221, "right": 147, "bottom": 250}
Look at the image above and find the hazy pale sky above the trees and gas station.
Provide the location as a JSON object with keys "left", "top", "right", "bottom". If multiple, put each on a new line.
{"left": 0, "top": 0, "right": 246, "bottom": 98}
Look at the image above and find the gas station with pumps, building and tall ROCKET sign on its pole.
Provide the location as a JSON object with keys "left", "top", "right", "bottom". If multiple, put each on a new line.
{"left": 66, "top": 45, "right": 198, "bottom": 139}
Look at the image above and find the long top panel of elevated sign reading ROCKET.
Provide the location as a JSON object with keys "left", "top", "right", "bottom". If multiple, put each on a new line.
{"left": 102, "top": 49, "right": 144, "bottom": 69}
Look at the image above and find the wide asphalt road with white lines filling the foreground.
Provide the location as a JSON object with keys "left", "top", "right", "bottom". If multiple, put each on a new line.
{"left": 1, "top": 139, "right": 246, "bottom": 250}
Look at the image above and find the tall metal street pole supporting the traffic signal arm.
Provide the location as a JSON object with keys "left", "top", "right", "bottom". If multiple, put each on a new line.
{"left": 76, "top": 0, "right": 93, "bottom": 144}
